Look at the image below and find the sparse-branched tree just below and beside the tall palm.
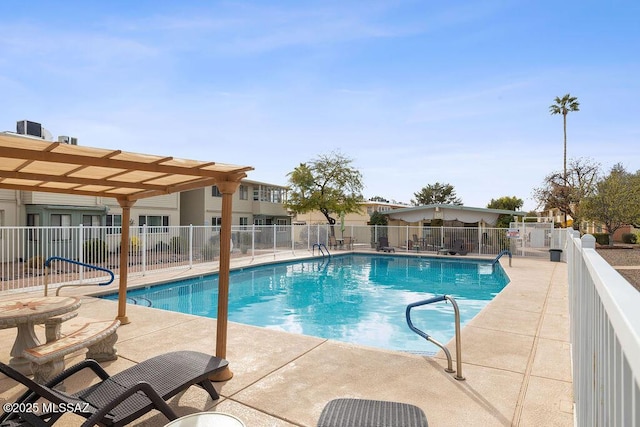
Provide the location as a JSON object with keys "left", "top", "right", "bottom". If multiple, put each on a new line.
{"left": 534, "top": 159, "right": 600, "bottom": 229}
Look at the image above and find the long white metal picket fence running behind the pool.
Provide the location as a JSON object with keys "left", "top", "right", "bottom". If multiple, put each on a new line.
{"left": 0, "top": 224, "right": 550, "bottom": 292}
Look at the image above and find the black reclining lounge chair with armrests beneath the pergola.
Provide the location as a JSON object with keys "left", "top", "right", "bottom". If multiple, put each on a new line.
{"left": 0, "top": 351, "right": 228, "bottom": 426}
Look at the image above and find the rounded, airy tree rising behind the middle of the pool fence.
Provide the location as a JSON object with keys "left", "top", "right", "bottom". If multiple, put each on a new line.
{"left": 285, "top": 152, "right": 364, "bottom": 236}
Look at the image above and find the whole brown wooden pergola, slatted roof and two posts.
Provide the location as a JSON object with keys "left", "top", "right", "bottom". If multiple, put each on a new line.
{"left": 0, "top": 133, "right": 253, "bottom": 380}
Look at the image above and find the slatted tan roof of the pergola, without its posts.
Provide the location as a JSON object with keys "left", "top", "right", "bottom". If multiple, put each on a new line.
{"left": 0, "top": 133, "right": 253, "bottom": 201}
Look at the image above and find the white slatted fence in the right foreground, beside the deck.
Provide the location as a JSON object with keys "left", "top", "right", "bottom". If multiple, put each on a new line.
{"left": 566, "top": 230, "right": 640, "bottom": 426}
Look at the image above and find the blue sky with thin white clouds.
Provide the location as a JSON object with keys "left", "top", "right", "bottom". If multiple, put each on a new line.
{"left": 0, "top": 0, "right": 640, "bottom": 210}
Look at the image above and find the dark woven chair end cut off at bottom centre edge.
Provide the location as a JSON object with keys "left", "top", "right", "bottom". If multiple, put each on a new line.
{"left": 317, "top": 399, "right": 429, "bottom": 427}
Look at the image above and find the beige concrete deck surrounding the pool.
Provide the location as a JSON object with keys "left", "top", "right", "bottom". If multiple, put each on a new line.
{"left": 0, "top": 258, "right": 573, "bottom": 427}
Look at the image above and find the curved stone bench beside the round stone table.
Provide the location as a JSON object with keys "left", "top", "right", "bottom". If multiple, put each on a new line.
{"left": 23, "top": 316, "right": 120, "bottom": 384}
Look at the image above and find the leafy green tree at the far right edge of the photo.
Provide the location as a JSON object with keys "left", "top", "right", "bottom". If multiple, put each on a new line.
{"left": 583, "top": 163, "right": 640, "bottom": 244}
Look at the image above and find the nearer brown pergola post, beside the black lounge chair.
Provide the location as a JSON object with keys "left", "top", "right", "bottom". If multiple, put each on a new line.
{"left": 210, "top": 181, "right": 240, "bottom": 381}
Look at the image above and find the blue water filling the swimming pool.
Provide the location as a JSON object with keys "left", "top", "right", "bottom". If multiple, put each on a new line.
{"left": 105, "top": 254, "right": 508, "bottom": 353}
